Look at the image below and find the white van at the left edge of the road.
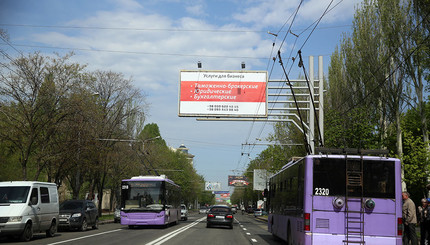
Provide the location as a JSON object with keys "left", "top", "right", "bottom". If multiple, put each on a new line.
{"left": 0, "top": 181, "right": 59, "bottom": 241}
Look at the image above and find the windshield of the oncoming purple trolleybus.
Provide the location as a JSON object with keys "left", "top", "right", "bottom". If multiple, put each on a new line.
{"left": 121, "top": 181, "right": 164, "bottom": 211}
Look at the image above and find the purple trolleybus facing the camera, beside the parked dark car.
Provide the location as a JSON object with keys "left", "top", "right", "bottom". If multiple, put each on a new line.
{"left": 121, "top": 175, "right": 181, "bottom": 228}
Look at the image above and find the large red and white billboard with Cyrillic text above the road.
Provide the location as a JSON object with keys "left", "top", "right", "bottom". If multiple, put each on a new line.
{"left": 178, "top": 70, "right": 267, "bottom": 117}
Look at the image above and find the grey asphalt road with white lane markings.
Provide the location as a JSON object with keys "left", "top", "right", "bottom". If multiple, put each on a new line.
{"left": 0, "top": 213, "right": 282, "bottom": 245}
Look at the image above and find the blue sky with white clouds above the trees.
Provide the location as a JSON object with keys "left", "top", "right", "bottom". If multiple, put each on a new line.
{"left": 0, "top": 0, "right": 361, "bottom": 193}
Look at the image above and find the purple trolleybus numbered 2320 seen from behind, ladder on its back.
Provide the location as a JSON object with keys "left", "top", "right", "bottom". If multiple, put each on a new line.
{"left": 268, "top": 151, "right": 402, "bottom": 245}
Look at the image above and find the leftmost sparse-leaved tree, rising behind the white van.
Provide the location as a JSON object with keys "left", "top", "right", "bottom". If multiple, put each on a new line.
{"left": 0, "top": 53, "right": 84, "bottom": 180}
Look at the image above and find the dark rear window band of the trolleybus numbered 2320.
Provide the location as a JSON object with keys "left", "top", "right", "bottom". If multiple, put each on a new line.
{"left": 313, "top": 158, "right": 395, "bottom": 199}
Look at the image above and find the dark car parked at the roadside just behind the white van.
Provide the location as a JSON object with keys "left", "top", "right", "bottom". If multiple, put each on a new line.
{"left": 58, "top": 200, "right": 99, "bottom": 231}
